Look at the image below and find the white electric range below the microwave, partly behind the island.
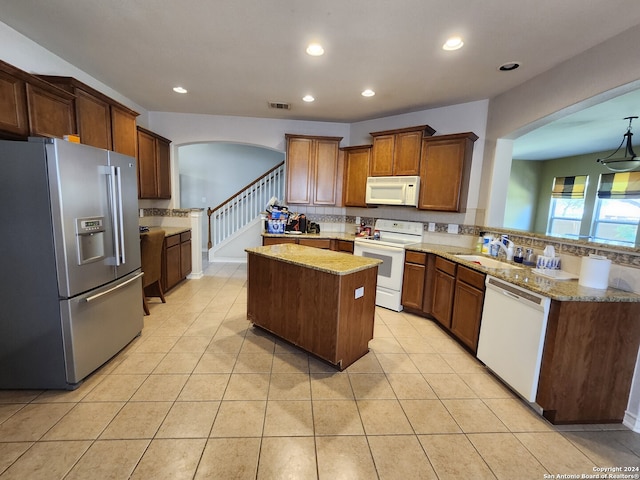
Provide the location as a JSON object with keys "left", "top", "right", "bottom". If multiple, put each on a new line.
{"left": 353, "top": 219, "right": 423, "bottom": 312}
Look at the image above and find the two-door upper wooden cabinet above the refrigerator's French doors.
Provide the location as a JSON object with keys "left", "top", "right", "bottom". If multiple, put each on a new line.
{"left": 39, "top": 75, "right": 138, "bottom": 157}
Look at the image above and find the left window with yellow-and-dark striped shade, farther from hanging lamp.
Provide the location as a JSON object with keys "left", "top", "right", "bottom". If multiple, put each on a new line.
{"left": 547, "top": 175, "right": 587, "bottom": 238}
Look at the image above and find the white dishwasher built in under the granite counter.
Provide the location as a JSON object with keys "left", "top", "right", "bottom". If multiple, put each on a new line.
{"left": 477, "top": 275, "right": 551, "bottom": 402}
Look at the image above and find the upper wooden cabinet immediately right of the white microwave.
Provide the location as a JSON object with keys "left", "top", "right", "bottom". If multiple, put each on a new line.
{"left": 418, "top": 132, "right": 478, "bottom": 212}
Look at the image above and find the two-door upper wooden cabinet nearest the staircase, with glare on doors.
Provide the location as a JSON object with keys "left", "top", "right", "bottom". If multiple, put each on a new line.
{"left": 285, "top": 134, "right": 342, "bottom": 205}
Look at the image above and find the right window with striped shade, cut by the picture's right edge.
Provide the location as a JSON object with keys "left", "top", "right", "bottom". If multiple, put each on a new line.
{"left": 591, "top": 172, "right": 640, "bottom": 247}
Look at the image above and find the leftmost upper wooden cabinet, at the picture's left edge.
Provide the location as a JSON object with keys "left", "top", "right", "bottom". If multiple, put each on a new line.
{"left": 0, "top": 61, "right": 75, "bottom": 140}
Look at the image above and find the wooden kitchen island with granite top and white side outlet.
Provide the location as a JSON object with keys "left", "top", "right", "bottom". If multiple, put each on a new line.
{"left": 246, "top": 244, "right": 382, "bottom": 370}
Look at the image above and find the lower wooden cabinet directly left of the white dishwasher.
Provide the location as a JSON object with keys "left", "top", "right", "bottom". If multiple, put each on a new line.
{"left": 451, "top": 265, "right": 485, "bottom": 353}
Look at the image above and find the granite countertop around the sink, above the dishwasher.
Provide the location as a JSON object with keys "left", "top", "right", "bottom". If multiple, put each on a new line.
{"left": 406, "top": 243, "right": 640, "bottom": 302}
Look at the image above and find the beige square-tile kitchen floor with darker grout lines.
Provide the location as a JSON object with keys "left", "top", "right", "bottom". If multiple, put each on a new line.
{"left": 0, "top": 264, "right": 640, "bottom": 480}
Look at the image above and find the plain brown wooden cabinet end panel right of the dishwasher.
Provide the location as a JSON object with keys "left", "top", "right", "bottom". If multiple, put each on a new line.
{"left": 536, "top": 300, "right": 640, "bottom": 424}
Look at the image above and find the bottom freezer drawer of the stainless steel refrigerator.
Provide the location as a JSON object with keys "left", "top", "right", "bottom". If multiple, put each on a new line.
{"left": 60, "top": 270, "right": 143, "bottom": 386}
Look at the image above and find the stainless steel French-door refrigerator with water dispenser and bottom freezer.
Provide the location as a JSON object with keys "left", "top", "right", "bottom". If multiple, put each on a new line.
{"left": 0, "top": 139, "right": 143, "bottom": 389}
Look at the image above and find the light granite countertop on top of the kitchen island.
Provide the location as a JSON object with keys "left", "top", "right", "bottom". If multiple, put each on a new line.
{"left": 245, "top": 246, "right": 382, "bottom": 275}
